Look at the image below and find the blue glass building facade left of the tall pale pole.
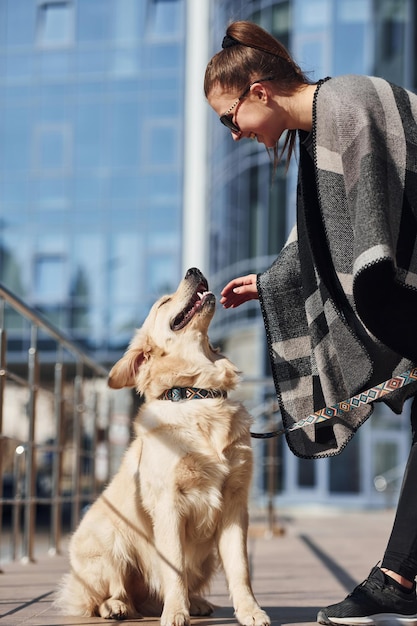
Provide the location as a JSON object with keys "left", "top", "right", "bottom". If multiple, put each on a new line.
{"left": 0, "top": 0, "right": 185, "bottom": 363}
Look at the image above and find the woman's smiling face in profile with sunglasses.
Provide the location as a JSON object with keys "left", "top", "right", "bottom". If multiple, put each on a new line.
{"left": 207, "top": 83, "right": 286, "bottom": 148}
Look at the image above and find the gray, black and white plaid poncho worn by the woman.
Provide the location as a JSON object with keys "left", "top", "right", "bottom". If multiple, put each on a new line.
{"left": 258, "top": 76, "right": 417, "bottom": 458}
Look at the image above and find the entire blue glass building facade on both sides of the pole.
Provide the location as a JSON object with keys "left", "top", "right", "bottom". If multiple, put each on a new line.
{"left": 0, "top": 0, "right": 417, "bottom": 505}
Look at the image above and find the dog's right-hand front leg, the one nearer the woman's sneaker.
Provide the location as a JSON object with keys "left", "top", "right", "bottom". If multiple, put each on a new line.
{"left": 219, "top": 511, "right": 271, "bottom": 626}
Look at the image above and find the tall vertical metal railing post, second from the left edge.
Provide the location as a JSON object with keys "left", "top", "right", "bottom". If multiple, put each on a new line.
{"left": 22, "top": 324, "right": 39, "bottom": 563}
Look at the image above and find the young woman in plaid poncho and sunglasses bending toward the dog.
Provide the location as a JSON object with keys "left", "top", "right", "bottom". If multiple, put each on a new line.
{"left": 204, "top": 22, "right": 417, "bottom": 625}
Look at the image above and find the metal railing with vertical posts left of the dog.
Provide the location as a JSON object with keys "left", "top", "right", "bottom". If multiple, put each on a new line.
{"left": 0, "top": 285, "right": 120, "bottom": 561}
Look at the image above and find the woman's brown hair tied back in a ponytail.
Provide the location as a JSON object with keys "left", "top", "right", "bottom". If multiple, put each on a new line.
{"left": 204, "top": 21, "right": 311, "bottom": 169}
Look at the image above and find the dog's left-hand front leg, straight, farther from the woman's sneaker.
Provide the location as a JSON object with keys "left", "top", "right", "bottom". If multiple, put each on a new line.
{"left": 154, "top": 501, "right": 190, "bottom": 626}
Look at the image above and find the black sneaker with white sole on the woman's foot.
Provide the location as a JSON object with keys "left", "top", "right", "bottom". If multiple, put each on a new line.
{"left": 317, "top": 567, "right": 417, "bottom": 626}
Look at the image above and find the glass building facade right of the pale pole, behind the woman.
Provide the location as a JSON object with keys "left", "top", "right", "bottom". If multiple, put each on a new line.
{"left": 209, "top": 0, "right": 417, "bottom": 506}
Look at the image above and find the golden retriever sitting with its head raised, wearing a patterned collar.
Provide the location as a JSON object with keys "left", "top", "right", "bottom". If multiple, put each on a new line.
{"left": 57, "top": 268, "right": 270, "bottom": 626}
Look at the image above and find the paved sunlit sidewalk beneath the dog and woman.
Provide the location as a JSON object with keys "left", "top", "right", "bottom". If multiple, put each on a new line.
{"left": 0, "top": 510, "right": 394, "bottom": 626}
